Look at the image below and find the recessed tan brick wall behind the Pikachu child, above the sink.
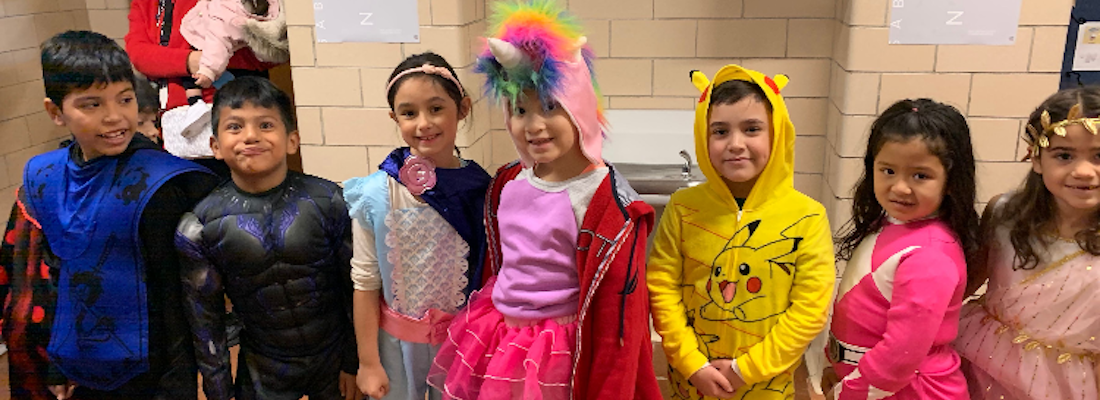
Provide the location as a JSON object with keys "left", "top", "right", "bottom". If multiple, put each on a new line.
{"left": 572, "top": 0, "right": 838, "bottom": 198}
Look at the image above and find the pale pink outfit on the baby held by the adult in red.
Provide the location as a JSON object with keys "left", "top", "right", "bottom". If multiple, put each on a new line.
{"left": 179, "top": 0, "right": 279, "bottom": 80}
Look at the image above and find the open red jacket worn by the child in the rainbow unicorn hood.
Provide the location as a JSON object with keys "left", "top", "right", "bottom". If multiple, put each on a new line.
{"left": 484, "top": 163, "right": 661, "bottom": 400}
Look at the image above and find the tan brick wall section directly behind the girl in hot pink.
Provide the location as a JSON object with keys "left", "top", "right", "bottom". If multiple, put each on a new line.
{"left": 823, "top": 0, "right": 1074, "bottom": 227}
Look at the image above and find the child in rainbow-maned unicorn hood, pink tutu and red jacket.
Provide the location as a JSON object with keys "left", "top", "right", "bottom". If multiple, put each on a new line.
{"left": 428, "top": 0, "right": 661, "bottom": 399}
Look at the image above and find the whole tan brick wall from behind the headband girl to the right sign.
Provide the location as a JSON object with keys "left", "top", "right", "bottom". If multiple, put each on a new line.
{"left": 287, "top": 0, "right": 1071, "bottom": 221}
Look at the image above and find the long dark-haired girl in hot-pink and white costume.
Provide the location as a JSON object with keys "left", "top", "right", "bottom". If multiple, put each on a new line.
{"left": 826, "top": 99, "right": 978, "bottom": 400}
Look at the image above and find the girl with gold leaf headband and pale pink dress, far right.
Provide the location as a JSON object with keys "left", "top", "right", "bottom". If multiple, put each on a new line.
{"left": 955, "top": 88, "right": 1100, "bottom": 400}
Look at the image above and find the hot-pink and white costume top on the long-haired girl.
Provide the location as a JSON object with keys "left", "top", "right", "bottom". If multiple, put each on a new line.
{"left": 827, "top": 219, "right": 968, "bottom": 400}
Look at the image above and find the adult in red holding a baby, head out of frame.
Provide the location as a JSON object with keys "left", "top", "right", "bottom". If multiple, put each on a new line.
{"left": 125, "top": 0, "right": 275, "bottom": 177}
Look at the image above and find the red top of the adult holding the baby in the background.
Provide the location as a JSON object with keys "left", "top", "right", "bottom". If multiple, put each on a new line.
{"left": 125, "top": 0, "right": 275, "bottom": 110}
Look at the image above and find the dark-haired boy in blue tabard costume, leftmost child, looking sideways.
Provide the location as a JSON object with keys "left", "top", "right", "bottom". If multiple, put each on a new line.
{"left": 18, "top": 31, "right": 216, "bottom": 399}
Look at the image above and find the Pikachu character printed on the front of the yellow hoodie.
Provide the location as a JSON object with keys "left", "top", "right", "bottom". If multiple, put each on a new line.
{"left": 700, "top": 220, "right": 802, "bottom": 322}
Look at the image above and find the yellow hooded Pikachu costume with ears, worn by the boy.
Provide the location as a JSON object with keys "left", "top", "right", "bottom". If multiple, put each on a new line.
{"left": 647, "top": 65, "right": 836, "bottom": 399}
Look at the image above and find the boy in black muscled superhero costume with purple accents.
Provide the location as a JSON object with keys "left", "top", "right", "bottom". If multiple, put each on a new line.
{"left": 176, "top": 77, "right": 359, "bottom": 400}
